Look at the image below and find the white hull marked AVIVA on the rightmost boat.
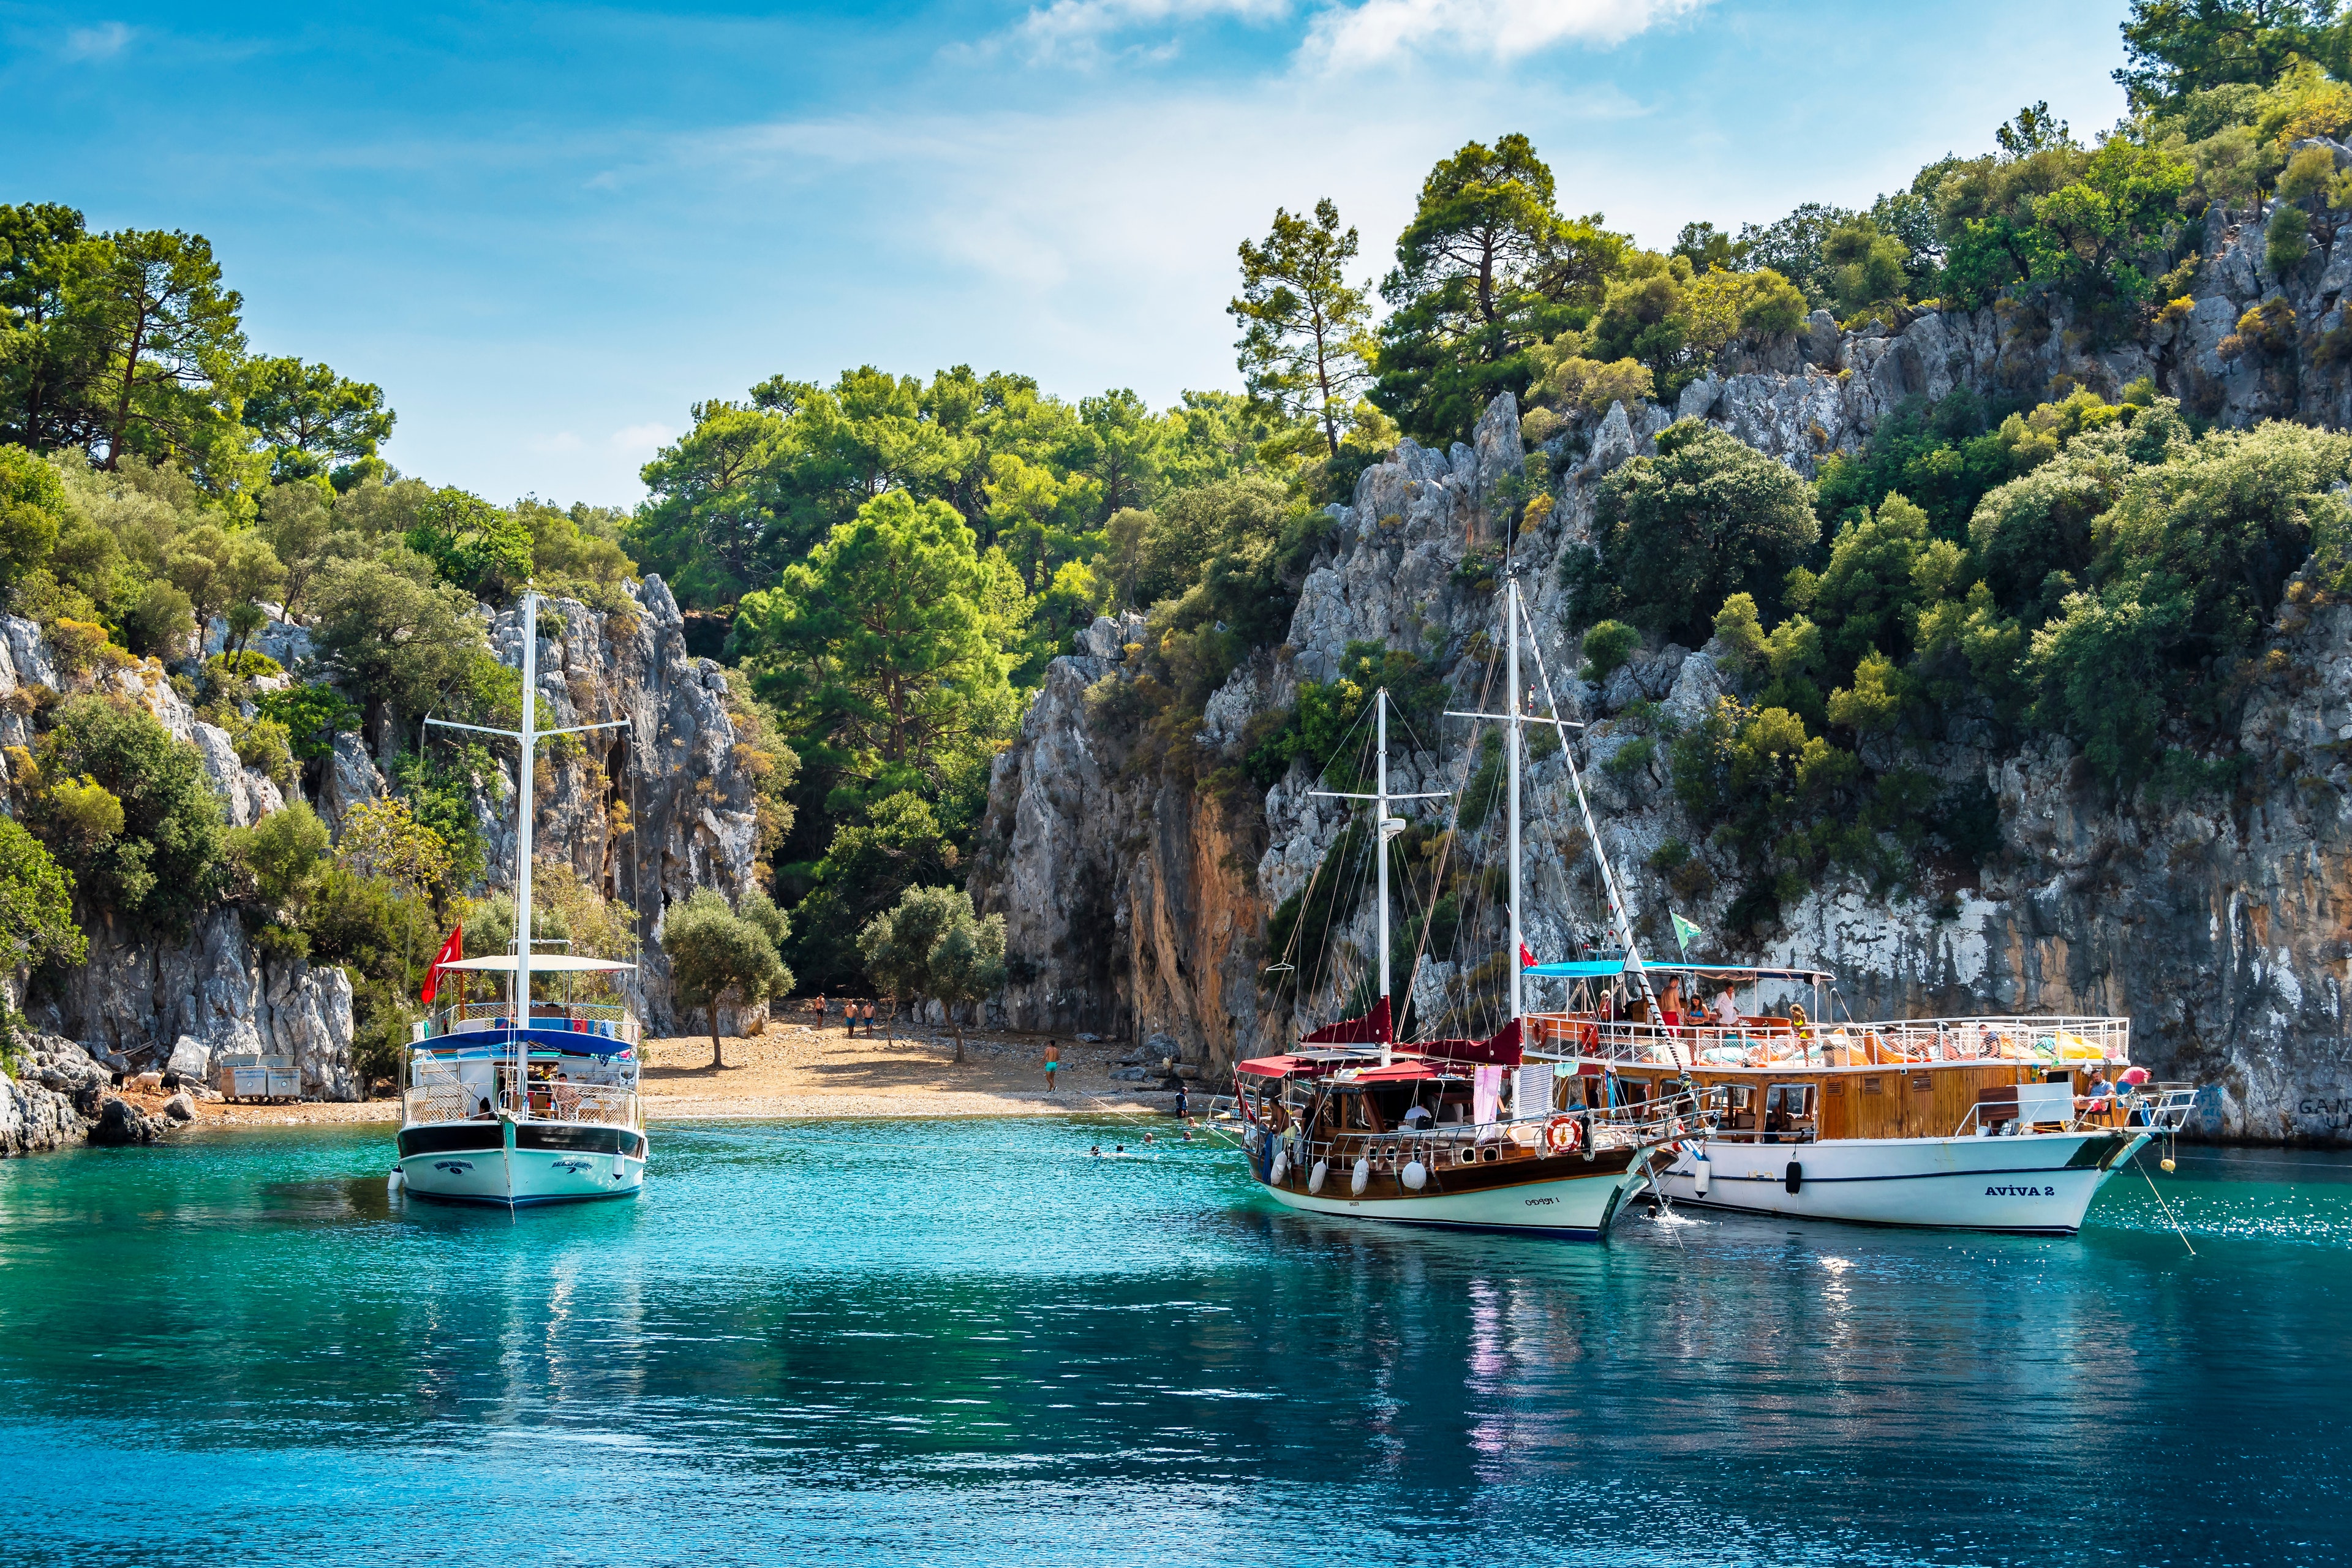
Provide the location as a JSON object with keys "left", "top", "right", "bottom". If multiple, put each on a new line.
{"left": 1658, "top": 1128, "right": 2147, "bottom": 1237}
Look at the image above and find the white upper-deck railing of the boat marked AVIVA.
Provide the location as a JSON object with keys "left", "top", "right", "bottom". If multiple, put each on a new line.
{"left": 1521, "top": 1013, "right": 2131, "bottom": 1067}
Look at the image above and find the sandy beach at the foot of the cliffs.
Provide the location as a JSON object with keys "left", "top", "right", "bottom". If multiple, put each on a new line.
{"left": 198, "top": 1023, "right": 1202, "bottom": 1126}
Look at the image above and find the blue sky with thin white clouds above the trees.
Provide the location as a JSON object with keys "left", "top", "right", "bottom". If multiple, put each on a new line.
{"left": 0, "top": 0, "right": 2124, "bottom": 503}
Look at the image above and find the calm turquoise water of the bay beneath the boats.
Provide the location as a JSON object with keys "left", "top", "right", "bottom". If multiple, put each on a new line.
{"left": 0, "top": 1119, "right": 2352, "bottom": 1568}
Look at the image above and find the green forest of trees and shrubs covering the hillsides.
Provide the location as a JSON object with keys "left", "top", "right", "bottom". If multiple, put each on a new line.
{"left": 0, "top": 0, "right": 2352, "bottom": 1039}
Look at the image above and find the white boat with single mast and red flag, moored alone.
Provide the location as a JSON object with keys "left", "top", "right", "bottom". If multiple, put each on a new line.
{"left": 390, "top": 592, "right": 647, "bottom": 1208}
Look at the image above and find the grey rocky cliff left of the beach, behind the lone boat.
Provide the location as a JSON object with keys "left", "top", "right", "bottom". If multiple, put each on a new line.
{"left": 0, "top": 578, "right": 755, "bottom": 1100}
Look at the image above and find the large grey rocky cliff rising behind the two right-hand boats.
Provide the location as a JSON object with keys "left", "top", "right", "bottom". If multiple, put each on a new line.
{"left": 971, "top": 175, "right": 2352, "bottom": 1142}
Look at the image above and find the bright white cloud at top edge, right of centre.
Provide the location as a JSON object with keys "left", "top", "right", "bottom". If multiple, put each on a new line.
{"left": 1298, "top": 0, "right": 1708, "bottom": 70}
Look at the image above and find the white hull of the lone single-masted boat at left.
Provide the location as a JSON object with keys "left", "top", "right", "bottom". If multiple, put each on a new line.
{"left": 400, "top": 1121, "right": 644, "bottom": 1208}
